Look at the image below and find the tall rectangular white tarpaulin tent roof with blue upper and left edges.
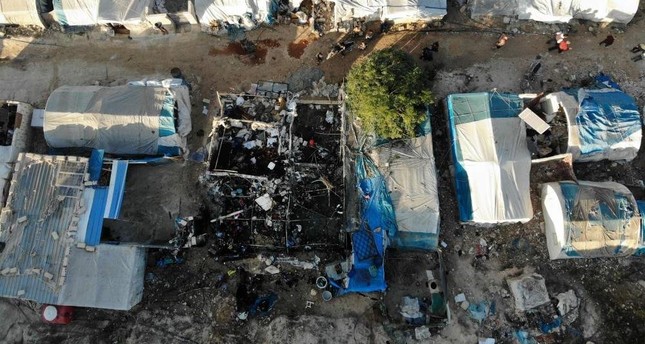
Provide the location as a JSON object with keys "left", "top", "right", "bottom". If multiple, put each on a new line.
{"left": 446, "top": 93, "right": 533, "bottom": 224}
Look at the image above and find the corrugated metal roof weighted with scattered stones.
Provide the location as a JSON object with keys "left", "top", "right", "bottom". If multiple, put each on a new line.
{"left": 0, "top": 154, "right": 88, "bottom": 303}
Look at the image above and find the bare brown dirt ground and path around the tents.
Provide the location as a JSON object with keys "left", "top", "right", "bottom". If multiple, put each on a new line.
{"left": 0, "top": 0, "right": 645, "bottom": 344}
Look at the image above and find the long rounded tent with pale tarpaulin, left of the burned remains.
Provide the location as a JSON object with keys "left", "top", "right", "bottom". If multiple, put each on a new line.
{"left": 43, "top": 79, "right": 191, "bottom": 155}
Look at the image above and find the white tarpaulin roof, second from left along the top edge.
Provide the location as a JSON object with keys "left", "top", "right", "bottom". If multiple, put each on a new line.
{"left": 53, "top": 0, "right": 150, "bottom": 26}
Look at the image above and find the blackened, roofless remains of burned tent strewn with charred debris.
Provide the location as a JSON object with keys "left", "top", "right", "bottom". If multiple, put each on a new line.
{"left": 202, "top": 92, "right": 345, "bottom": 259}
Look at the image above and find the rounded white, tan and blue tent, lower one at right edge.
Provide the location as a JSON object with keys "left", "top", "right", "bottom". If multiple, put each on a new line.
{"left": 542, "top": 181, "right": 641, "bottom": 259}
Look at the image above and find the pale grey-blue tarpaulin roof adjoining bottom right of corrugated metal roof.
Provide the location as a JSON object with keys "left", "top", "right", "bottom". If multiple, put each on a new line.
{"left": 57, "top": 244, "right": 146, "bottom": 311}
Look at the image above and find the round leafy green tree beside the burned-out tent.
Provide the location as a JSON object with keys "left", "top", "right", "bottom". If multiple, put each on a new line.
{"left": 347, "top": 49, "right": 434, "bottom": 139}
